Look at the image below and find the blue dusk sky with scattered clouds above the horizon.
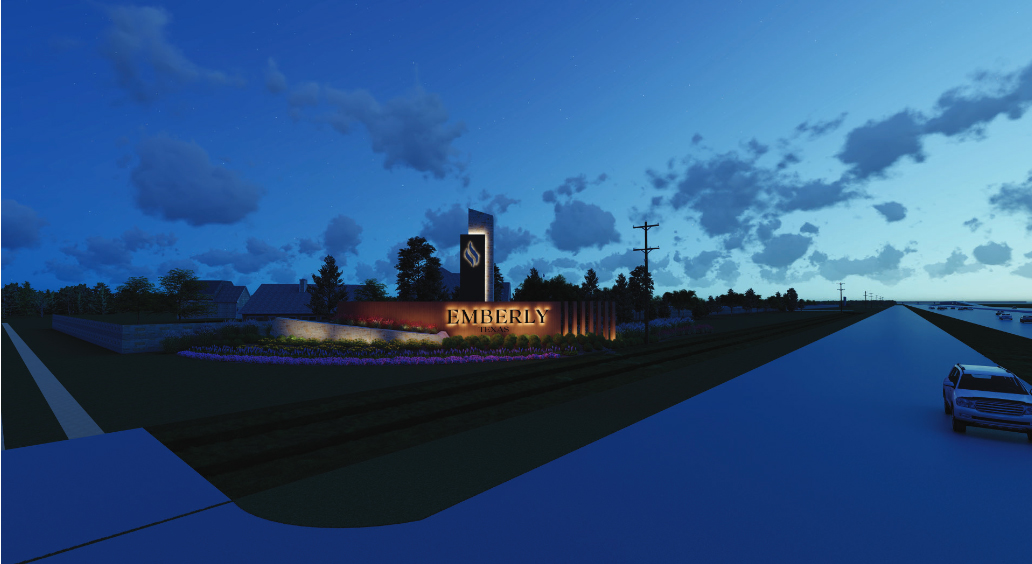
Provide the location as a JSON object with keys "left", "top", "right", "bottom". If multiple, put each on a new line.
{"left": 2, "top": 0, "right": 1032, "bottom": 300}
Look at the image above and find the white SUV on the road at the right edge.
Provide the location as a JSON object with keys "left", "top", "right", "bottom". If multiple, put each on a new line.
{"left": 942, "top": 364, "right": 1032, "bottom": 441}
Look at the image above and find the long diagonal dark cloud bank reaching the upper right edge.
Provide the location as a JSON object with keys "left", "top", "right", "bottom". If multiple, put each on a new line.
{"left": 838, "top": 64, "right": 1032, "bottom": 178}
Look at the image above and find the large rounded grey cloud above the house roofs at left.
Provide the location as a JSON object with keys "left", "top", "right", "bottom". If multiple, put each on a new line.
{"left": 130, "top": 134, "right": 265, "bottom": 227}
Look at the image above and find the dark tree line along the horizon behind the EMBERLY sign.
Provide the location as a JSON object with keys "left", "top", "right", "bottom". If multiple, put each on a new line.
{"left": 3, "top": 231, "right": 807, "bottom": 323}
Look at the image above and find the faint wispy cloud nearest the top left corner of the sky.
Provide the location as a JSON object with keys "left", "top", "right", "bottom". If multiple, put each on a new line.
{"left": 100, "top": 6, "right": 240, "bottom": 102}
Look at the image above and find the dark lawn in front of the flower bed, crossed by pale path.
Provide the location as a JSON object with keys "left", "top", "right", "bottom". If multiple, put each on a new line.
{"left": 3, "top": 317, "right": 553, "bottom": 445}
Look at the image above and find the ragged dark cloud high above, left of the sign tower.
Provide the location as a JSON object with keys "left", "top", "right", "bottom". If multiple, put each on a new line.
{"left": 318, "top": 87, "right": 469, "bottom": 185}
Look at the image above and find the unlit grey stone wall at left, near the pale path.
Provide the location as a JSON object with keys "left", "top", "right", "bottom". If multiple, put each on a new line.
{"left": 51, "top": 316, "right": 271, "bottom": 354}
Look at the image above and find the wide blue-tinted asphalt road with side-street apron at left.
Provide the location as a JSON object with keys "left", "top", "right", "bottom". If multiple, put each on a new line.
{"left": 2, "top": 306, "right": 1032, "bottom": 564}
